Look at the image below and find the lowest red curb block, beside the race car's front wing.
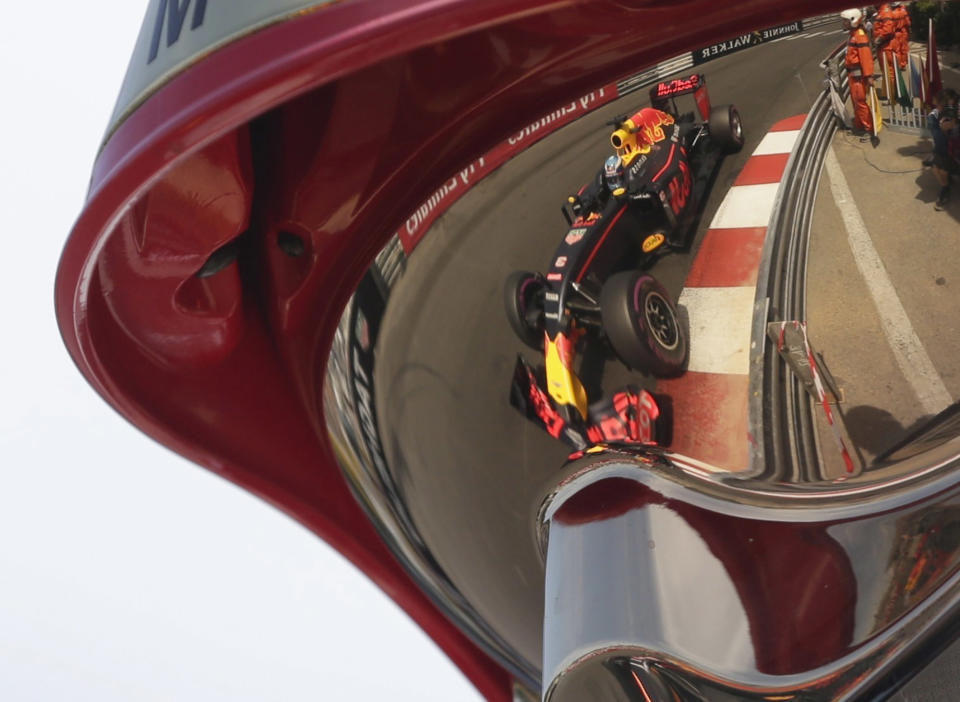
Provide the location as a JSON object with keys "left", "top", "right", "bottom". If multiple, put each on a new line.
{"left": 657, "top": 372, "right": 750, "bottom": 471}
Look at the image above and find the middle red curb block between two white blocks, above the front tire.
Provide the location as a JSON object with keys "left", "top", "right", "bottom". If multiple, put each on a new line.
{"left": 686, "top": 227, "right": 767, "bottom": 288}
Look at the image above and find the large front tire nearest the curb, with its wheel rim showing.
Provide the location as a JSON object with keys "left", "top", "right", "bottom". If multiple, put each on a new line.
{"left": 600, "top": 271, "right": 688, "bottom": 378}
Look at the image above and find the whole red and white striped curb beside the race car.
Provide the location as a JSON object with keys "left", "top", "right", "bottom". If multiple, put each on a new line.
{"left": 657, "top": 115, "right": 806, "bottom": 471}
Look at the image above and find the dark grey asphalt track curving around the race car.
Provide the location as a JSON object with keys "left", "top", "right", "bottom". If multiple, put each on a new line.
{"left": 375, "top": 28, "right": 842, "bottom": 667}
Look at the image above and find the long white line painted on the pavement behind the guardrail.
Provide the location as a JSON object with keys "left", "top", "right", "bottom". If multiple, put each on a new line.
{"left": 825, "top": 146, "right": 953, "bottom": 414}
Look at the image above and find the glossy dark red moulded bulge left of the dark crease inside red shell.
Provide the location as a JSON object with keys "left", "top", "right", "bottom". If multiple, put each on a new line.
{"left": 97, "top": 130, "right": 253, "bottom": 370}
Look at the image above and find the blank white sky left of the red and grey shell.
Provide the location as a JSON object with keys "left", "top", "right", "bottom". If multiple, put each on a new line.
{"left": 0, "top": 0, "right": 479, "bottom": 702}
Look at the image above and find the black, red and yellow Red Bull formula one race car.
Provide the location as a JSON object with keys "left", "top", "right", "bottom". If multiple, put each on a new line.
{"left": 504, "top": 74, "right": 743, "bottom": 448}
